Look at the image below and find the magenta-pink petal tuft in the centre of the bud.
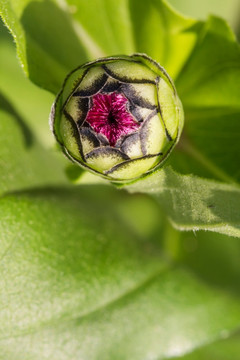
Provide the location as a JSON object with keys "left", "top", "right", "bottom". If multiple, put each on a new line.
{"left": 86, "top": 92, "right": 140, "bottom": 146}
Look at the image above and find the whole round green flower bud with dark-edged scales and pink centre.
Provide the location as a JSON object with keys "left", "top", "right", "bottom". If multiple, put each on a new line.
{"left": 50, "top": 54, "right": 183, "bottom": 182}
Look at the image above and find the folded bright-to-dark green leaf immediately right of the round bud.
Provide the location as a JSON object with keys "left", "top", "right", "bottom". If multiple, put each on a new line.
{"left": 172, "top": 17, "right": 240, "bottom": 182}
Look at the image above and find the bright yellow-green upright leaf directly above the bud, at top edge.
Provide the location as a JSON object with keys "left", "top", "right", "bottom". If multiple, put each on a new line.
{"left": 67, "top": 0, "right": 136, "bottom": 55}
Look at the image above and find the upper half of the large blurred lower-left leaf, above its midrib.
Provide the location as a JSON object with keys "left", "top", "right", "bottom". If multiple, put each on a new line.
{"left": 0, "top": 186, "right": 165, "bottom": 337}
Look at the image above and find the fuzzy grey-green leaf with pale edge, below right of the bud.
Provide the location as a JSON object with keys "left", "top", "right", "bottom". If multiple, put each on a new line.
{"left": 125, "top": 167, "right": 240, "bottom": 237}
